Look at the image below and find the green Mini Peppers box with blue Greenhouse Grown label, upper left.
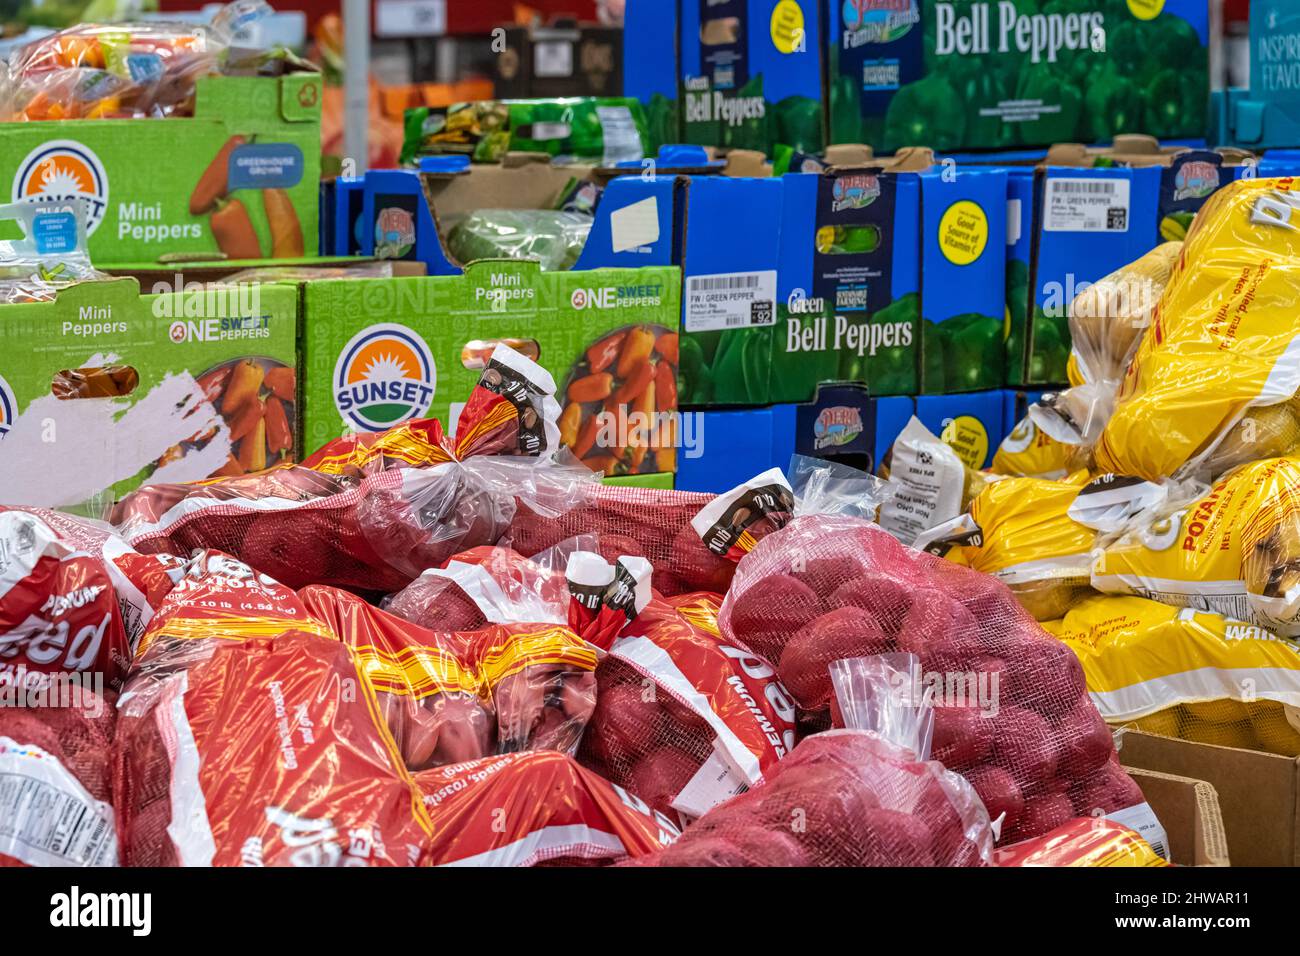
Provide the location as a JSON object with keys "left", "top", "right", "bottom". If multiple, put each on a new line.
{"left": 0, "top": 73, "right": 321, "bottom": 267}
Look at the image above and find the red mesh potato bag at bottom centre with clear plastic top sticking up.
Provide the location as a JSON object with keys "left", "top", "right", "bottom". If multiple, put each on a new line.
{"left": 625, "top": 661, "right": 993, "bottom": 866}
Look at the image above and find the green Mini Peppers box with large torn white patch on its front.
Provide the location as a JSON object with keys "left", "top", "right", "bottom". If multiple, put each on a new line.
{"left": 0, "top": 278, "right": 299, "bottom": 514}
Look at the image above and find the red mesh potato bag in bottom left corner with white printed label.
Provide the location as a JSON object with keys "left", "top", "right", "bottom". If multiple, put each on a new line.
{"left": 0, "top": 684, "right": 118, "bottom": 866}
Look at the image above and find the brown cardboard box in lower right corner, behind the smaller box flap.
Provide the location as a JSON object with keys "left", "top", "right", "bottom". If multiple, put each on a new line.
{"left": 1119, "top": 731, "right": 1300, "bottom": 866}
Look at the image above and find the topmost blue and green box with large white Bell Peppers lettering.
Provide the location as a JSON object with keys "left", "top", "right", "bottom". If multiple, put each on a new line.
{"left": 827, "top": 0, "right": 1211, "bottom": 151}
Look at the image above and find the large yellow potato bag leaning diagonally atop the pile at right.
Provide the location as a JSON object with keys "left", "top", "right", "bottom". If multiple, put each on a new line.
{"left": 1095, "top": 179, "right": 1300, "bottom": 480}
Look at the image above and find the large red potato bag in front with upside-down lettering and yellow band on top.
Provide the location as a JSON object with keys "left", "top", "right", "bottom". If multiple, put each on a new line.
{"left": 113, "top": 551, "right": 429, "bottom": 866}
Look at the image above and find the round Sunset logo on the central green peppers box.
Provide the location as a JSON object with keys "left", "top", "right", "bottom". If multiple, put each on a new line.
{"left": 334, "top": 325, "right": 438, "bottom": 432}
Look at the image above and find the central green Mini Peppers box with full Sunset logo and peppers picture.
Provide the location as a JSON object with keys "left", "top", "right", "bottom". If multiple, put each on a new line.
{"left": 302, "top": 259, "right": 681, "bottom": 476}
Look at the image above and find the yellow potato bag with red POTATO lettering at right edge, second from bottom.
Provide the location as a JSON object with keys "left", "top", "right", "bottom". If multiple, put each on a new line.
{"left": 1092, "top": 457, "right": 1300, "bottom": 637}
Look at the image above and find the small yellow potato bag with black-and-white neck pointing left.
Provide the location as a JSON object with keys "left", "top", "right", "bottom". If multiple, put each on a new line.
{"left": 915, "top": 472, "right": 1096, "bottom": 620}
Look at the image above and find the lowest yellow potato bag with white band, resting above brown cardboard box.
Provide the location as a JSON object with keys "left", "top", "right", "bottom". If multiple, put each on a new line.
{"left": 1044, "top": 596, "right": 1300, "bottom": 757}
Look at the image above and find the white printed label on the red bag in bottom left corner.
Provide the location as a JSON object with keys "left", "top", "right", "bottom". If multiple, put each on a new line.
{"left": 0, "top": 736, "right": 117, "bottom": 866}
